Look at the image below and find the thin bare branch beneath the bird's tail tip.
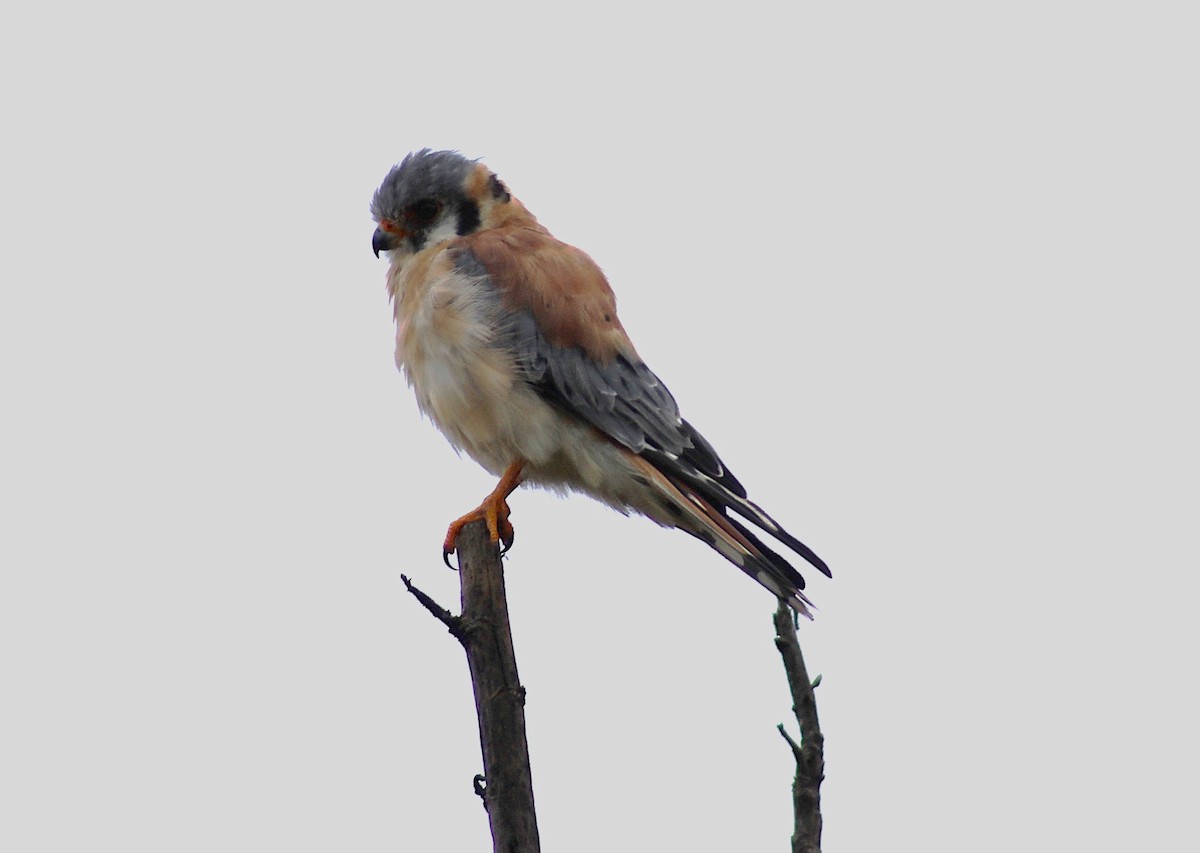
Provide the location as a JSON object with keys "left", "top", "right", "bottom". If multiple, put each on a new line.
{"left": 774, "top": 600, "right": 824, "bottom": 853}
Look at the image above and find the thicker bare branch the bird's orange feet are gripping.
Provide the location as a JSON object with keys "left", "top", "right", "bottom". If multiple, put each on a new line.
{"left": 403, "top": 521, "right": 541, "bottom": 853}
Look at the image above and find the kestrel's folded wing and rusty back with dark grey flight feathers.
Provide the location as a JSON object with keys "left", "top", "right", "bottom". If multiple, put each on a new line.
{"left": 455, "top": 235, "right": 829, "bottom": 590}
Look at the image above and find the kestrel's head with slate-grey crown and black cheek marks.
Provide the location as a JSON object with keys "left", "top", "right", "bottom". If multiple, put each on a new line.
{"left": 371, "top": 149, "right": 512, "bottom": 257}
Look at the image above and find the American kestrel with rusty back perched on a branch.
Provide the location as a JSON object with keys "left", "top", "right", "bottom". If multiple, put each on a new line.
{"left": 371, "top": 149, "right": 829, "bottom": 615}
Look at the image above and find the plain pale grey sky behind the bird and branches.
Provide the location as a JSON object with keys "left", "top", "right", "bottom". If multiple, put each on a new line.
{"left": 0, "top": 1, "right": 1200, "bottom": 853}
